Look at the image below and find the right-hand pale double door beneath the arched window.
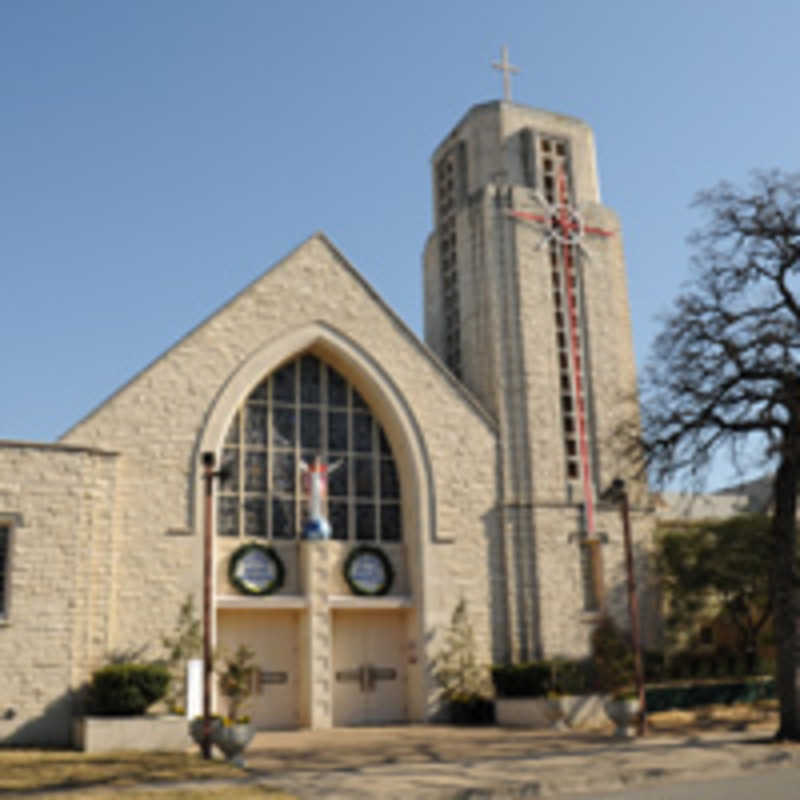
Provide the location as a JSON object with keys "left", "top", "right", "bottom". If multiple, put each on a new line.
{"left": 333, "top": 609, "right": 408, "bottom": 725}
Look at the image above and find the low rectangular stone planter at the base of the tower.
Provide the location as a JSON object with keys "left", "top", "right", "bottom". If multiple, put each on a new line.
{"left": 495, "top": 694, "right": 607, "bottom": 728}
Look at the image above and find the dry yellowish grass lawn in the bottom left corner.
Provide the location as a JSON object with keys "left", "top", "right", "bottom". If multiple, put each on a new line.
{"left": 0, "top": 748, "right": 290, "bottom": 800}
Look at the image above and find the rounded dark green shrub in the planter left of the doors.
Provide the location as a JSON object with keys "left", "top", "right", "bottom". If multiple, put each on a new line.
{"left": 88, "top": 664, "right": 169, "bottom": 716}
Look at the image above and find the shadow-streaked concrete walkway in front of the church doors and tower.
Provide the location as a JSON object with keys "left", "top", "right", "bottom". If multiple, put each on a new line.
{"left": 241, "top": 725, "right": 800, "bottom": 800}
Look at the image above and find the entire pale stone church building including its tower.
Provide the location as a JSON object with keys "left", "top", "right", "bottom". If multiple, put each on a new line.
{"left": 0, "top": 86, "right": 656, "bottom": 744}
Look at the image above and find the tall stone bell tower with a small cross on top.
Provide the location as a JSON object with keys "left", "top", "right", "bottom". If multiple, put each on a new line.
{"left": 424, "top": 81, "right": 636, "bottom": 659}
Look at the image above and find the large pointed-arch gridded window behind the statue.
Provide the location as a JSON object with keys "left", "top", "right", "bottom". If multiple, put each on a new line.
{"left": 217, "top": 354, "right": 402, "bottom": 542}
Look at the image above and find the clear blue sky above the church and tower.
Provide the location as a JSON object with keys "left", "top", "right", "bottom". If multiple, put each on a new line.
{"left": 0, "top": 0, "right": 800, "bottom": 488}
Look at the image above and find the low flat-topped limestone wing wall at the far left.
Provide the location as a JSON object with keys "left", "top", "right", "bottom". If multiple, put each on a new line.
{"left": 0, "top": 442, "right": 118, "bottom": 745}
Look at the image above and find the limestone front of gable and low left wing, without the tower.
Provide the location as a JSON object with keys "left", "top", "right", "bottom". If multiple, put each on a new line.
{"left": 0, "top": 235, "right": 496, "bottom": 742}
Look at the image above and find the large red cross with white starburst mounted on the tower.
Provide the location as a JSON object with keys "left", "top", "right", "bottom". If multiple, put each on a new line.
{"left": 508, "top": 169, "right": 614, "bottom": 538}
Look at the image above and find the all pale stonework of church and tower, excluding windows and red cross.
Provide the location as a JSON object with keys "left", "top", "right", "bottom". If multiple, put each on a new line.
{"left": 0, "top": 103, "right": 651, "bottom": 744}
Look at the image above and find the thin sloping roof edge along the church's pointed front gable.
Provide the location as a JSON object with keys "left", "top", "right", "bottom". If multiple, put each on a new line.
{"left": 61, "top": 230, "right": 497, "bottom": 444}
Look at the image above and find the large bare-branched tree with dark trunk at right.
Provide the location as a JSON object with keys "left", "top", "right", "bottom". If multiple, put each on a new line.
{"left": 642, "top": 171, "right": 800, "bottom": 739}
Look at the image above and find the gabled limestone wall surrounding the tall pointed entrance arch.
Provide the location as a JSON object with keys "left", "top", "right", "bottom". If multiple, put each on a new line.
{"left": 59, "top": 236, "right": 496, "bottom": 720}
